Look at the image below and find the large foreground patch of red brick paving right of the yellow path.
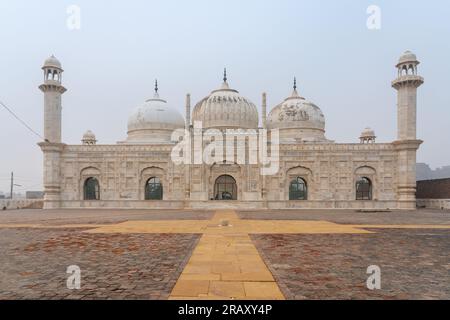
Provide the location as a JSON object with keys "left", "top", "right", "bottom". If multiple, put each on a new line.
{"left": 252, "top": 229, "right": 450, "bottom": 299}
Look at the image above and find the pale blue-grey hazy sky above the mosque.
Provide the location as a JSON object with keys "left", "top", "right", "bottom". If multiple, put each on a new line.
{"left": 0, "top": 0, "right": 450, "bottom": 191}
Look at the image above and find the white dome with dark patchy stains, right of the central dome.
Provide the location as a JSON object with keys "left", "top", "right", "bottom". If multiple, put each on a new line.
{"left": 267, "top": 84, "right": 326, "bottom": 141}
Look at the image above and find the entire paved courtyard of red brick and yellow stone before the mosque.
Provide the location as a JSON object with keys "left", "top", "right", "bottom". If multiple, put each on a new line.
{"left": 0, "top": 210, "right": 450, "bottom": 299}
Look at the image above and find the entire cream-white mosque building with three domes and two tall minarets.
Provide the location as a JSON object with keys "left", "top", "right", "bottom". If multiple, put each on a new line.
{"left": 39, "top": 52, "right": 423, "bottom": 209}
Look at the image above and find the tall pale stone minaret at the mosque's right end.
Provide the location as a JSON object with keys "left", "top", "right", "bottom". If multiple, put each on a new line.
{"left": 392, "top": 51, "right": 424, "bottom": 209}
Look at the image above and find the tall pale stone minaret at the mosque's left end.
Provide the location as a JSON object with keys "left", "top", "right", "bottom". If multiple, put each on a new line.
{"left": 39, "top": 56, "right": 66, "bottom": 209}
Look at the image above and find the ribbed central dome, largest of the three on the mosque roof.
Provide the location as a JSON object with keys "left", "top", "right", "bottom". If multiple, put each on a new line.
{"left": 192, "top": 73, "right": 259, "bottom": 129}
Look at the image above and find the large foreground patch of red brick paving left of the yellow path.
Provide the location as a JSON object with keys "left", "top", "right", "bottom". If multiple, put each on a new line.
{"left": 0, "top": 229, "right": 199, "bottom": 299}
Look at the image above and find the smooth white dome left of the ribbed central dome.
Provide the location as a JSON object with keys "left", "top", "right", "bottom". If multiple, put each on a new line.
{"left": 127, "top": 88, "right": 185, "bottom": 143}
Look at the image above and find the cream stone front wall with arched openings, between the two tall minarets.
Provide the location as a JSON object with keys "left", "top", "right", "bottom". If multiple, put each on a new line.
{"left": 55, "top": 143, "right": 397, "bottom": 209}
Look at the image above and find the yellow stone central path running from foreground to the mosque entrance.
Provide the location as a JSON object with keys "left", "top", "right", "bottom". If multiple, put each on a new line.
{"left": 170, "top": 212, "right": 284, "bottom": 300}
